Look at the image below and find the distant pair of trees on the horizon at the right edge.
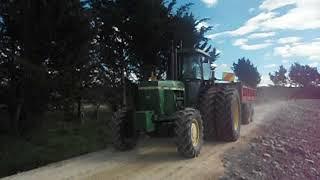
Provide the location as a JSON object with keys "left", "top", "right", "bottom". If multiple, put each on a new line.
{"left": 269, "top": 63, "right": 320, "bottom": 87}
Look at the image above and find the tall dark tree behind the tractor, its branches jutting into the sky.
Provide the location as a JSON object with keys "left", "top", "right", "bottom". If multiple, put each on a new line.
{"left": 88, "top": 0, "right": 218, "bottom": 105}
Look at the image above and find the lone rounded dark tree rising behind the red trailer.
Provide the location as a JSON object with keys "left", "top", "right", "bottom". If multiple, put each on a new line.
{"left": 232, "top": 57, "right": 261, "bottom": 87}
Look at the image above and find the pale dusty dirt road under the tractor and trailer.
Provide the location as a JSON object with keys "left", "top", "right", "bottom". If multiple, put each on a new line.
{"left": 4, "top": 101, "right": 310, "bottom": 180}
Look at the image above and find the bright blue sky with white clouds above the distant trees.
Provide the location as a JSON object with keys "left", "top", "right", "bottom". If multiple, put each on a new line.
{"left": 179, "top": 0, "right": 320, "bottom": 85}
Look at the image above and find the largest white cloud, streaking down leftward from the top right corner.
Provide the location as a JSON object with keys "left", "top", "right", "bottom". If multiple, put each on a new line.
{"left": 209, "top": 0, "right": 320, "bottom": 38}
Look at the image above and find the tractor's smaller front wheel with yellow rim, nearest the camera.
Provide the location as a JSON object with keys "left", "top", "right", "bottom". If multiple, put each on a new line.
{"left": 175, "top": 108, "right": 203, "bottom": 158}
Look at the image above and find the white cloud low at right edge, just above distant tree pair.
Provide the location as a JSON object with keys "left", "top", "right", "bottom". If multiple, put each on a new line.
{"left": 274, "top": 38, "right": 320, "bottom": 61}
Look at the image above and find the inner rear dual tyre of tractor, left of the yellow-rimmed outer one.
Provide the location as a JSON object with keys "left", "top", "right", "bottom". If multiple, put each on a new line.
{"left": 199, "top": 87, "right": 219, "bottom": 140}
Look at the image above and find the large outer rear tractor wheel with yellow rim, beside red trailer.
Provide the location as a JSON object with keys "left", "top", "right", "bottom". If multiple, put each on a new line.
{"left": 215, "top": 88, "right": 241, "bottom": 141}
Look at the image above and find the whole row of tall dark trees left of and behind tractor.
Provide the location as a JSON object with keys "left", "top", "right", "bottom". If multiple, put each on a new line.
{"left": 0, "top": 0, "right": 217, "bottom": 133}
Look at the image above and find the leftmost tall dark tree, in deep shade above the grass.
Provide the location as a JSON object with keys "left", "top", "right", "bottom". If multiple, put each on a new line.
{"left": 0, "top": 0, "right": 90, "bottom": 131}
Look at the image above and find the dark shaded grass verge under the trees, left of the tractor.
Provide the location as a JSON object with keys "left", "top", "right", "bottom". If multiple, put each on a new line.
{"left": 0, "top": 106, "right": 111, "bottom": 177}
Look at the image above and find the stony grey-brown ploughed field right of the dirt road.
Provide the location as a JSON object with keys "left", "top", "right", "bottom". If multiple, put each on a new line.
{"left": 221, "top": 100, "right": 320, "bottom": 180}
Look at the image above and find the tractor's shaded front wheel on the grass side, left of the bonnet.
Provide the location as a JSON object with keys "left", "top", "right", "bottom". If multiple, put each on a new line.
{"left": 109, "top": 108, "right": 138, "bottom": 151}
